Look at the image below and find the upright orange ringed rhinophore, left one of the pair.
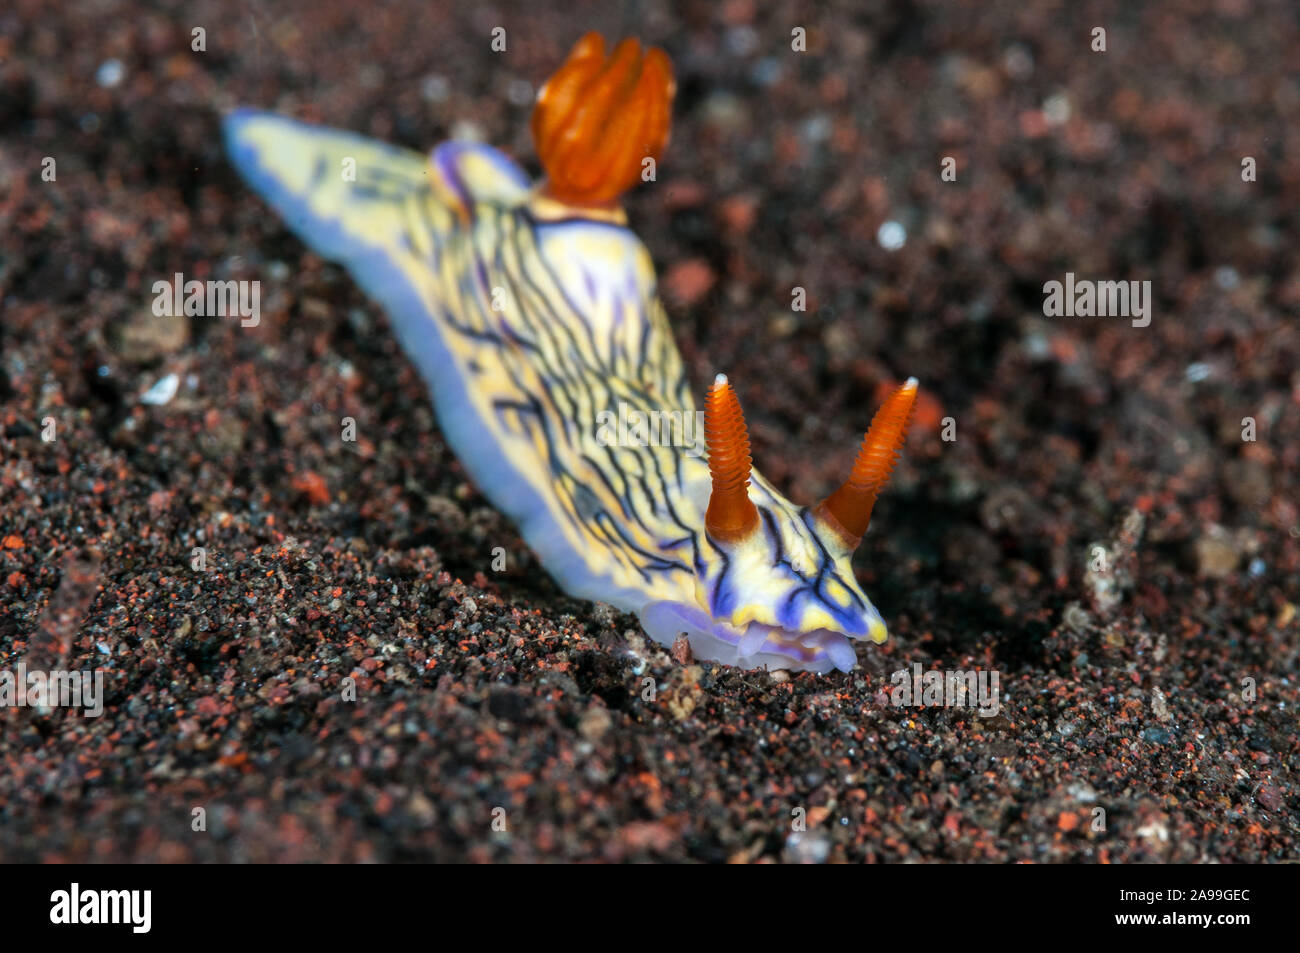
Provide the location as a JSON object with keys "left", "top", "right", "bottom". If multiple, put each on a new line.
{"left": 705, "top": 374, "right": 758, "bottom": 542}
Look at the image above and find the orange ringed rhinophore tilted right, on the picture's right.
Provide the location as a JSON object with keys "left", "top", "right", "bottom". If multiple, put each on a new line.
{"left": 816, "top": 377, "right": 917, "bottom": 547}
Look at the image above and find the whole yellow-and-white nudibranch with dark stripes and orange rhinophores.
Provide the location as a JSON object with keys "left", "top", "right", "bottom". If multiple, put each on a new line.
{"left": 225, "top": 34, "right": 917, "bottom": 672}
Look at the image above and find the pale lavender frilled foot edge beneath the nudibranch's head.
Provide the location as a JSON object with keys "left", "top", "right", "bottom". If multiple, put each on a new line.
{"left": 641, "top": 602, "right": 858, "bottom": 673}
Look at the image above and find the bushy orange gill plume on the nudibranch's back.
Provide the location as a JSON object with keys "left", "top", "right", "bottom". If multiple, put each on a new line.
{"left": 533, "top": 33, "right": 676, "bottom": 205}
